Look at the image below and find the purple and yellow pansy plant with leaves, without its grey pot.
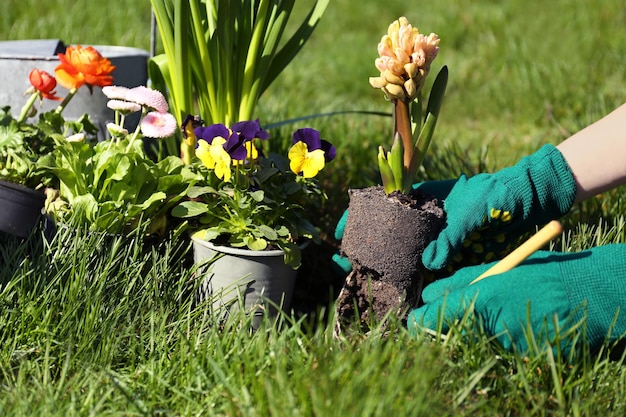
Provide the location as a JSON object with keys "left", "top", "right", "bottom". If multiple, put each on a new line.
{"left": 172, "top": 117, "right": 336, "bottom": 268}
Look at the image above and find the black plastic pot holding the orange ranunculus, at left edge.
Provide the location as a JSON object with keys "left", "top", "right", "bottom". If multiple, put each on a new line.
{"left": 0, "top": 180, "right": 46, "bottom": 237}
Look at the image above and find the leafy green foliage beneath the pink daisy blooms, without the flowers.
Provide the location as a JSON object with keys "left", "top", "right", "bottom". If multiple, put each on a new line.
{"left": 38, "top": 139, "right": 197, "bottom": 234}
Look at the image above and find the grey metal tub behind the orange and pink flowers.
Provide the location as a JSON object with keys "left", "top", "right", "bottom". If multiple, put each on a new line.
{"left": 0, "top": 39, "right": 149, "bottom": 138}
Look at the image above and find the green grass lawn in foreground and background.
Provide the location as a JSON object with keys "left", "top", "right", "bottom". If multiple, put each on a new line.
{"left": 0, "top": 0, "right": 626, "bottom": 416}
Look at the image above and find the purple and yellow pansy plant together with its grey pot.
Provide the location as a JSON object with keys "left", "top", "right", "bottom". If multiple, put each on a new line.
{"left": 172, "top": 118, "right": 336, "bottom": 325}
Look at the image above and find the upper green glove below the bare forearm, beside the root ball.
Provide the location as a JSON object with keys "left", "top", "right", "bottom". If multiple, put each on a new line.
{"left": 422, "top": 145, "right": 576, "bottom": 271}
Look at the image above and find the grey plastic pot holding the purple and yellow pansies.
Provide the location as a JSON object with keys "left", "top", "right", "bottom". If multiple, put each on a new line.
{"left": 193, "top": 238, "right": 297, "bottom": 328}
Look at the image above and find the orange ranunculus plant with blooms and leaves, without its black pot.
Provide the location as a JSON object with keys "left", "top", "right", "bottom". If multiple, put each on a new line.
{"left": 0, "top": 45, "right": 115, "bottom": 189}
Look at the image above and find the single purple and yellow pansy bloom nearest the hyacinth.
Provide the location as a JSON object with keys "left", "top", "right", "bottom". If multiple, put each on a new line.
{"left": 288, "top": 128, "right": 337, "bottom": 178}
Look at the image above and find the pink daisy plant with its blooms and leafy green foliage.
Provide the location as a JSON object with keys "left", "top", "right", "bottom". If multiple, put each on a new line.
{"left": 38, "top": 86, "right": 198, "bottom": 236}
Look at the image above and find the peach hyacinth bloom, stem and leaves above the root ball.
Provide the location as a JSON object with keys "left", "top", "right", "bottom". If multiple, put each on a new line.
{"left": 370, "top": 17, "right": 448, "bottom": 194}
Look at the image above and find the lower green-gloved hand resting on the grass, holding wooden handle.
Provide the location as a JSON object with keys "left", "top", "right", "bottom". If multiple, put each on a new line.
{"left": 407, "top": 244, "right": 626, "bottom": 352}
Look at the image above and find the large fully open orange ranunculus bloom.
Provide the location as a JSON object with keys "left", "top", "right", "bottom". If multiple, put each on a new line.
{"left": 54, "top": 45, "right": 115, "bottom": 90}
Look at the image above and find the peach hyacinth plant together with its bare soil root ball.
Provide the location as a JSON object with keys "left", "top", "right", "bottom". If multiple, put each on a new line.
{"left": 336, "top": 17, "right": 448, "bottom": 323}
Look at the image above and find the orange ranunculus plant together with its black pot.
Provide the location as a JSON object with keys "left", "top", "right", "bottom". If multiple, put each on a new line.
{"left": 0, "top": 46, "right": 115, "bottom": 237}
